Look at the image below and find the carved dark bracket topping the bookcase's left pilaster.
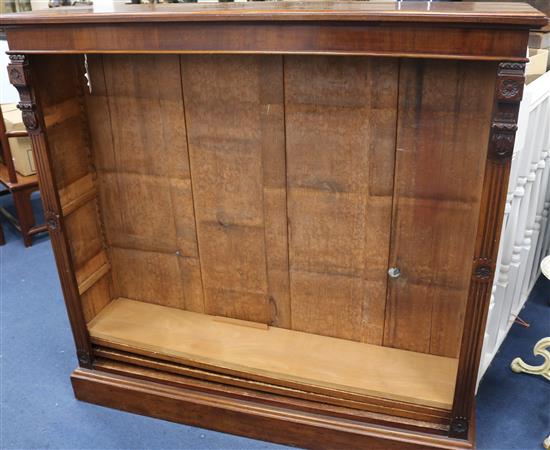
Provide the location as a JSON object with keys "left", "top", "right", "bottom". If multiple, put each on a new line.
{"left": 8, "top": 55, "right": 40, "bottom": 134}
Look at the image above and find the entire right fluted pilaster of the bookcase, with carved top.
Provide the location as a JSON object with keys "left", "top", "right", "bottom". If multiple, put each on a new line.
{"left": 449, "top": 61, "right": 525, "bottom": 438}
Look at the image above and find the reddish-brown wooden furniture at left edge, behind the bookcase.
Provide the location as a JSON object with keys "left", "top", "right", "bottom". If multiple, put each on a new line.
{"left": 0, "top": 104, "right": 47, "bottom": 247}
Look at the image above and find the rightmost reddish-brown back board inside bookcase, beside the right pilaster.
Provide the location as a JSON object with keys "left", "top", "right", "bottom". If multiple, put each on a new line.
{"left": 384, "top": 60, "right": 496, "bottom": 356}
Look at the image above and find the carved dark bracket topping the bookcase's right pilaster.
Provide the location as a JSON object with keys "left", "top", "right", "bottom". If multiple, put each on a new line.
{"left": 489, "top": 62, "right": 525, "bottom": 163}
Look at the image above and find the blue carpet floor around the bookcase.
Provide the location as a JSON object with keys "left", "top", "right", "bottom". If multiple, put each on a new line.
{"left": 0, "top": 192, "right": 550, "bottom": 450}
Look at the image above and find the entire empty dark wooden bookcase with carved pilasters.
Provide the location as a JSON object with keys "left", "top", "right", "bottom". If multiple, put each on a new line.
{"left": 2, "top": 2, "right": 546, "bottom": 449}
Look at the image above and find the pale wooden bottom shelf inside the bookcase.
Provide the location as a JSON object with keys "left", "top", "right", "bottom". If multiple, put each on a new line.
{"left": 88, "top": 298, "right": 458, "bottom": 409}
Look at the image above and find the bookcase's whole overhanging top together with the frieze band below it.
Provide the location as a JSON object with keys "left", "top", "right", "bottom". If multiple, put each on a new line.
{"left": 0, "top": 1, "right": 547, "bottom": 62}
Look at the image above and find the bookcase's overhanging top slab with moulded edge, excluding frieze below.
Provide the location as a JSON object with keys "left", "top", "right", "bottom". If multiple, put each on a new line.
{"left": 0, "top": 1, "right": 547, "bottom": 27}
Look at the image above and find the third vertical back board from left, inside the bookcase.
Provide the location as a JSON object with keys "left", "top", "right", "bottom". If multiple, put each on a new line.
{"left": 284, "top": 56, "right": 399, "bottom": 344}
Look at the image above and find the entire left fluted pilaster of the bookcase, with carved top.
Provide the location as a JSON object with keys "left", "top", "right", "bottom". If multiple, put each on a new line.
{"left": 8, "top": 55, "right": 92, "bottom": 367}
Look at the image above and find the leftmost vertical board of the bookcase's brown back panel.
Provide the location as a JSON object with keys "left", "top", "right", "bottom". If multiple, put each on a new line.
{"left": 87, "top": 55, "right": 204, "bottom": 312}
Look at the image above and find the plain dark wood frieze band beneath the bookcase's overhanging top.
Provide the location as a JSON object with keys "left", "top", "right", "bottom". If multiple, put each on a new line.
{"left": 7, "top": 22, "right": 528, "bottom": 61}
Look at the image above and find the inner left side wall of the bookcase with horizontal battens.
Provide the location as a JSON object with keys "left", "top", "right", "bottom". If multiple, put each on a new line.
{"left": 35, "top": 56, "right": 111, "bottom": 321}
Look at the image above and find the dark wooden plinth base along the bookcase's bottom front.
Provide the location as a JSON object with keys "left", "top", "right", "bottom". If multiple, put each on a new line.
{"left": 71, "top": 369, "right": 473, "bottom": 450}
